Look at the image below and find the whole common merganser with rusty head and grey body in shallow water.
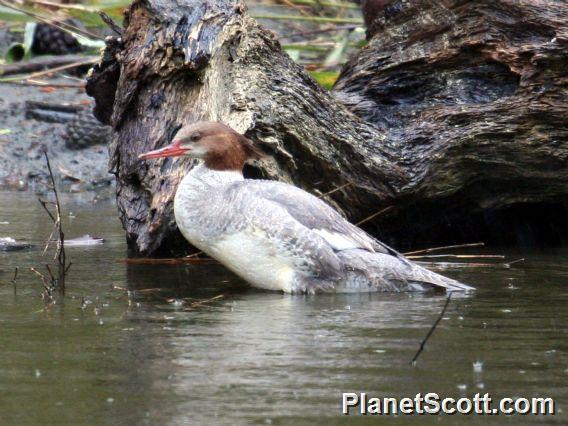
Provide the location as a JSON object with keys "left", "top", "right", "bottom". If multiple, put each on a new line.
{"left": 139, "top": 122, "right": 473, "bottom": 294}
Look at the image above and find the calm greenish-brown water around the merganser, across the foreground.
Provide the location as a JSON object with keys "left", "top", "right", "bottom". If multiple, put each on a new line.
{"left": 0, "top": 192, "right": 568, "bottom": 424}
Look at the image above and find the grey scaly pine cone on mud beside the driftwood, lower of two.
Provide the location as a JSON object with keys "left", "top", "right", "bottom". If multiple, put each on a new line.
{"left": 65, "top": 109, "right": 111, "bottom": 149}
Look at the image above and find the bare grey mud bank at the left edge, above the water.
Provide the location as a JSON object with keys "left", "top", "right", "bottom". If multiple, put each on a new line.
{"left": 0, "top": 80, "right": 113, "bottom": 192}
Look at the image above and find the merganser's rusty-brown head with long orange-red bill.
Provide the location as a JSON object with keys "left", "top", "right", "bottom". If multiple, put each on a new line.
{"left": 138, "top": 121, "right": 263, "bottom": 171}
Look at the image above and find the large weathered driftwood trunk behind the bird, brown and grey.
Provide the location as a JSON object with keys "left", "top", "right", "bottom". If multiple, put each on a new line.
{"left": 87, "top": 0, "right": 568, "bottom": 253}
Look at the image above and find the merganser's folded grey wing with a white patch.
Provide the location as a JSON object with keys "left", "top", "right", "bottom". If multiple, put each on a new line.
{"left": 233, "top": 180, "right": 408, "bottom": 262}
